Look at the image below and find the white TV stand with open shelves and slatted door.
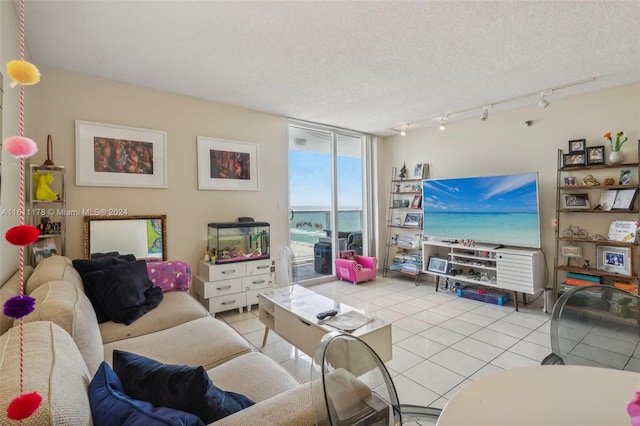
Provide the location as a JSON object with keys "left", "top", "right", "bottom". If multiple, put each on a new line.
{"left": 422, "top": 241, "right": 545, "bottom": 311}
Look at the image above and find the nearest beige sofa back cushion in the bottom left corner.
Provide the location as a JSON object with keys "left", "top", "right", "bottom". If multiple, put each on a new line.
{"left": 0, "top": 321, "right": 91, "bottom": 425}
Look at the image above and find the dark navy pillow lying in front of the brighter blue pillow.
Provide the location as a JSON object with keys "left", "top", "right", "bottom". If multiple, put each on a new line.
{"left": 113, "top": 350, "right": 255, "bottom": 424}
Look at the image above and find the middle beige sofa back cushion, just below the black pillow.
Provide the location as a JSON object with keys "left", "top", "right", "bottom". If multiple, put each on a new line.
{"left": 24, "top": 281, "right": 104, "bottom": 375}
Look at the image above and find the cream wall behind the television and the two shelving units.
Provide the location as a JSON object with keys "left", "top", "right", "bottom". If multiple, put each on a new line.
{"left": 378, "top": 84, "right": 640, "bottom": 283}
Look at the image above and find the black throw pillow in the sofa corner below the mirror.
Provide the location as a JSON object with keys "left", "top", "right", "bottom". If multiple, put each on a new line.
{"left": 83, "top": 260, "right": 162, "bottom": 324}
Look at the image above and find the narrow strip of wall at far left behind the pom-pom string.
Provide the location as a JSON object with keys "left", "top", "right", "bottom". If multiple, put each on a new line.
{"left": 0, "top": 1, "right": 22, "bottom": 283}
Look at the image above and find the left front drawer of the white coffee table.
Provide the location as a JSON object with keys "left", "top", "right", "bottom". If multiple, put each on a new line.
{"left": 274, "top": 305, "right": 327, "bottom": 357}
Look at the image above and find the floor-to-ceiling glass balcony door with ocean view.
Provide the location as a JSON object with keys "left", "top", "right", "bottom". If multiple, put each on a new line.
{"left": 289, "top": 120, "right": 370, "bottom": 282}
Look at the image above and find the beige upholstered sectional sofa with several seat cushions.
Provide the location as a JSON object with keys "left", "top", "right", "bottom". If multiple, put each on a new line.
{"left": 0, "top": 256, "right": 314, "bottom": 426}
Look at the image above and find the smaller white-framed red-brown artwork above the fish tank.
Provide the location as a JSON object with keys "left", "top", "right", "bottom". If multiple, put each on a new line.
{"left": 197, "top": 136, "right": 260, "bottom": 191}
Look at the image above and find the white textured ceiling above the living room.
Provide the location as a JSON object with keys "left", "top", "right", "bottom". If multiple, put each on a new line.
{"left": 16, "top": 0, "right": 640, "bottom": 134}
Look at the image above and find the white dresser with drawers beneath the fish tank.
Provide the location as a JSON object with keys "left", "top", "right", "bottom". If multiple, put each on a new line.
{"left": 193, "top": 259, "right": 275, "bottom": 314}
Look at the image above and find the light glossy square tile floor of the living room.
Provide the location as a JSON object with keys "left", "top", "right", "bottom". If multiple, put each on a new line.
{"left": 218, "top": 276, "right": 551, "bottom": 407}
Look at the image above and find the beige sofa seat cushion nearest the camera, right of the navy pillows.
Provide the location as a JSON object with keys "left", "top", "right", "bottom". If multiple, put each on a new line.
{"left": 207, "top": 352, "right": 302, "bottom": 402}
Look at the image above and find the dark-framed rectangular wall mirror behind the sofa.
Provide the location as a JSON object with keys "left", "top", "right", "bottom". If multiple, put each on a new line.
{"left": 84, "top": 215, "right": 167, "bottom": 260}
